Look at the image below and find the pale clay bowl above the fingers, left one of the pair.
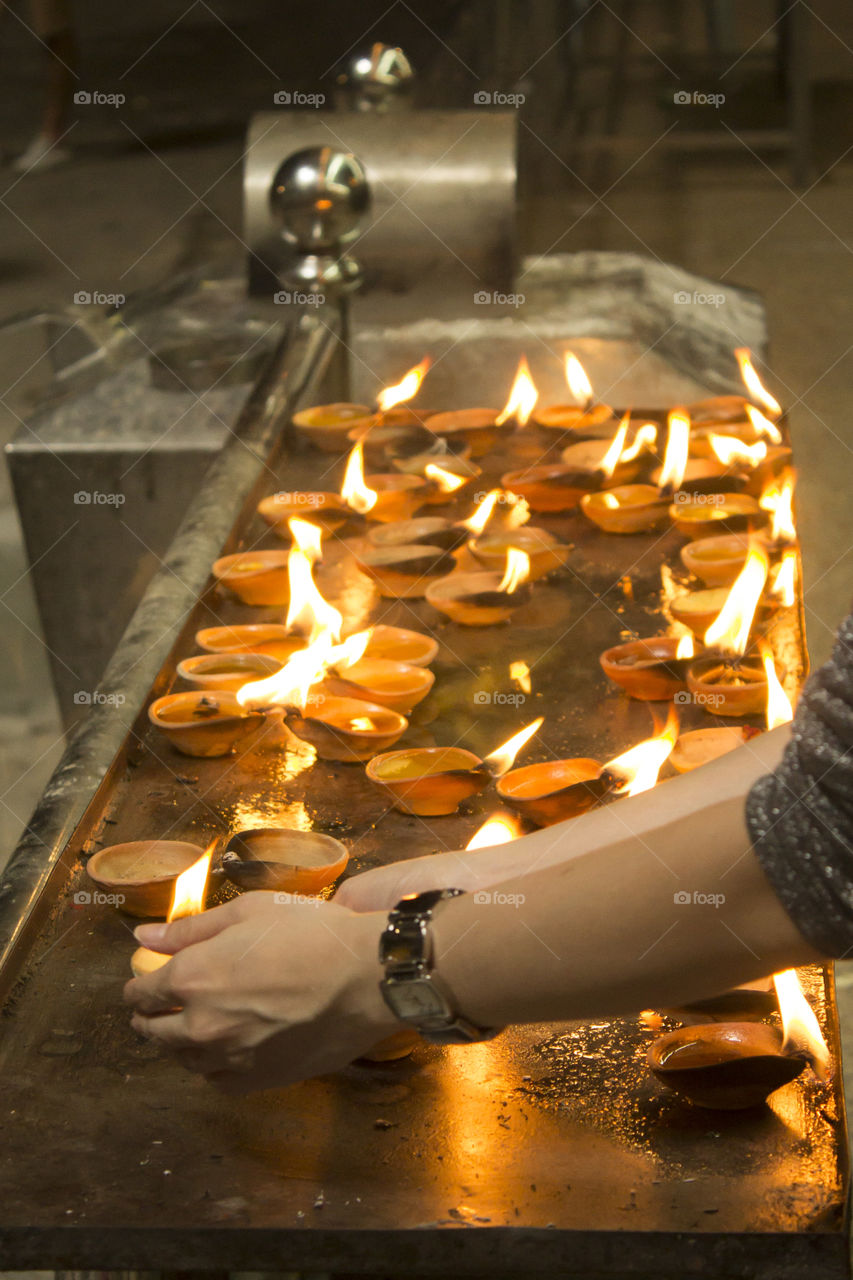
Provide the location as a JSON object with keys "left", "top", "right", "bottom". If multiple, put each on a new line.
{"left": 86, "top": 840, "right": 204, "bottom": 919}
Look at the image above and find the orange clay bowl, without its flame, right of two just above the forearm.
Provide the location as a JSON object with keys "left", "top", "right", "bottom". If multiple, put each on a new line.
{"left": 497, "top": 756, "right": 619, "bottom": 827}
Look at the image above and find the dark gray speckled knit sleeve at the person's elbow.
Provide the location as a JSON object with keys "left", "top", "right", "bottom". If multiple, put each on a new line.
{"left": 747, "top": 604, "right": 853, "bottom": 956}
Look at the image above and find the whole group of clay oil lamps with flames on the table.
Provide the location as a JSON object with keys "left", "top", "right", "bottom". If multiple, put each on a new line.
{"left": 88, "top": 351, "right": 820, "bottom": 1106}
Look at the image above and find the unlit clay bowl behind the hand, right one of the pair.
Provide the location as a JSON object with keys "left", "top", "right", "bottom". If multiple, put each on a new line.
{"left": 219, "top": 827, "right": 350, "bottom": 896}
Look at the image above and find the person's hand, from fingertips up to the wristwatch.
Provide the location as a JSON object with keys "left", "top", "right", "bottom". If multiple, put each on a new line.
{"left": 124, "top": 893, "right": 400, "bottom": 1093}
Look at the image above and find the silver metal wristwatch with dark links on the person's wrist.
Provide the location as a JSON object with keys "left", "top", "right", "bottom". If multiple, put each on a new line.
{"left": 379, "top": 888, "right": 503, "bottom": 1044}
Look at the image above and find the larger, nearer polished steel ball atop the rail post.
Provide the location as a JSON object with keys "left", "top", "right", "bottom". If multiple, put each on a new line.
{"left": 270, "top": 147, "right": 370, "bottom": 253}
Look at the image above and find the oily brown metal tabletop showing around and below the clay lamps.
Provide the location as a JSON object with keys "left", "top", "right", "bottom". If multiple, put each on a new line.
{"left": 0, "top": 391, "right": 848, "bottom": 1280}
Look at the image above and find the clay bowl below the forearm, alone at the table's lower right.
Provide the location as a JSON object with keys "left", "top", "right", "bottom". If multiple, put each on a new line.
{"left": 648, "top": 1023, "right": 806, "bottom": 1111}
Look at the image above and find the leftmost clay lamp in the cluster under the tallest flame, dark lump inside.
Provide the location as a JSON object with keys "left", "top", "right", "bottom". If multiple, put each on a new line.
{"left": 149, "top": 689, "right": 264, "bottom": 758}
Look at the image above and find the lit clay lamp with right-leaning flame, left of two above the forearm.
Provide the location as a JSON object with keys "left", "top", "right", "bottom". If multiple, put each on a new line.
{"left": 366, "top": 718, "right": 543, "bottom": 818}
